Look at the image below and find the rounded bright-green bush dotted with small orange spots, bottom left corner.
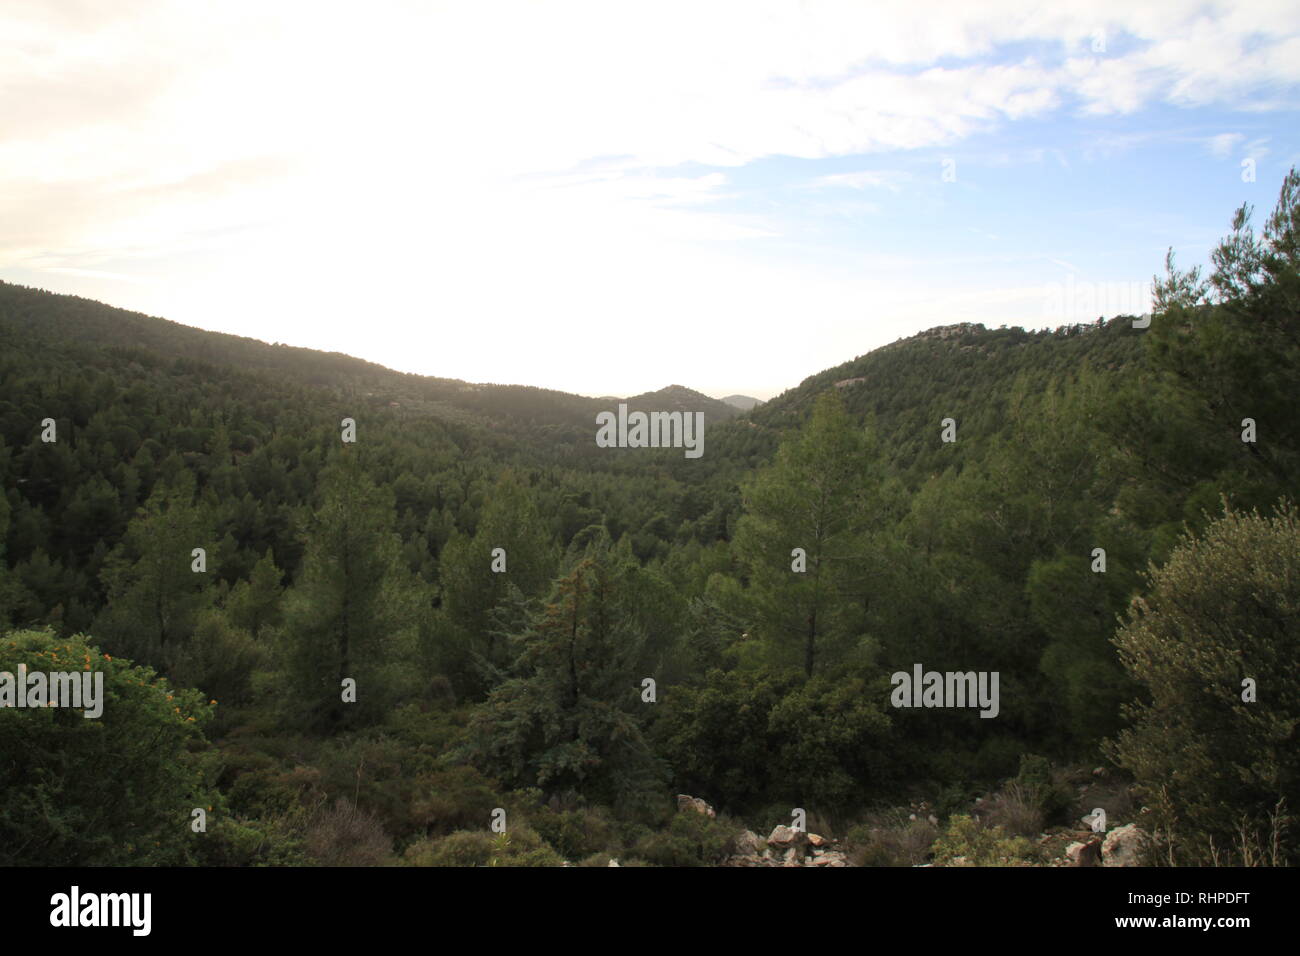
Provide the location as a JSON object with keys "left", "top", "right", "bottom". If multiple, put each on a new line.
{"left": 0, "top": 631, "right": 224, "bottom": 866}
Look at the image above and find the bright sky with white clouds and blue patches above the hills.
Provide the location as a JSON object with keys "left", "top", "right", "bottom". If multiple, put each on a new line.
{"left": 0, "top": 0, "right": 1300, "bottom": 399}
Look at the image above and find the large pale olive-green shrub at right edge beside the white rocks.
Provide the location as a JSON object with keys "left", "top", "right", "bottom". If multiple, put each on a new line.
{"left": 1108, "top": 503, "right": 1300, "bottom": 864}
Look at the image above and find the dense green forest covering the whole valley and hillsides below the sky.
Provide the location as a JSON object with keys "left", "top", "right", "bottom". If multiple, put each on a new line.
{"left": 0, "top": 170, "right": 1300, "bottom": 865}
